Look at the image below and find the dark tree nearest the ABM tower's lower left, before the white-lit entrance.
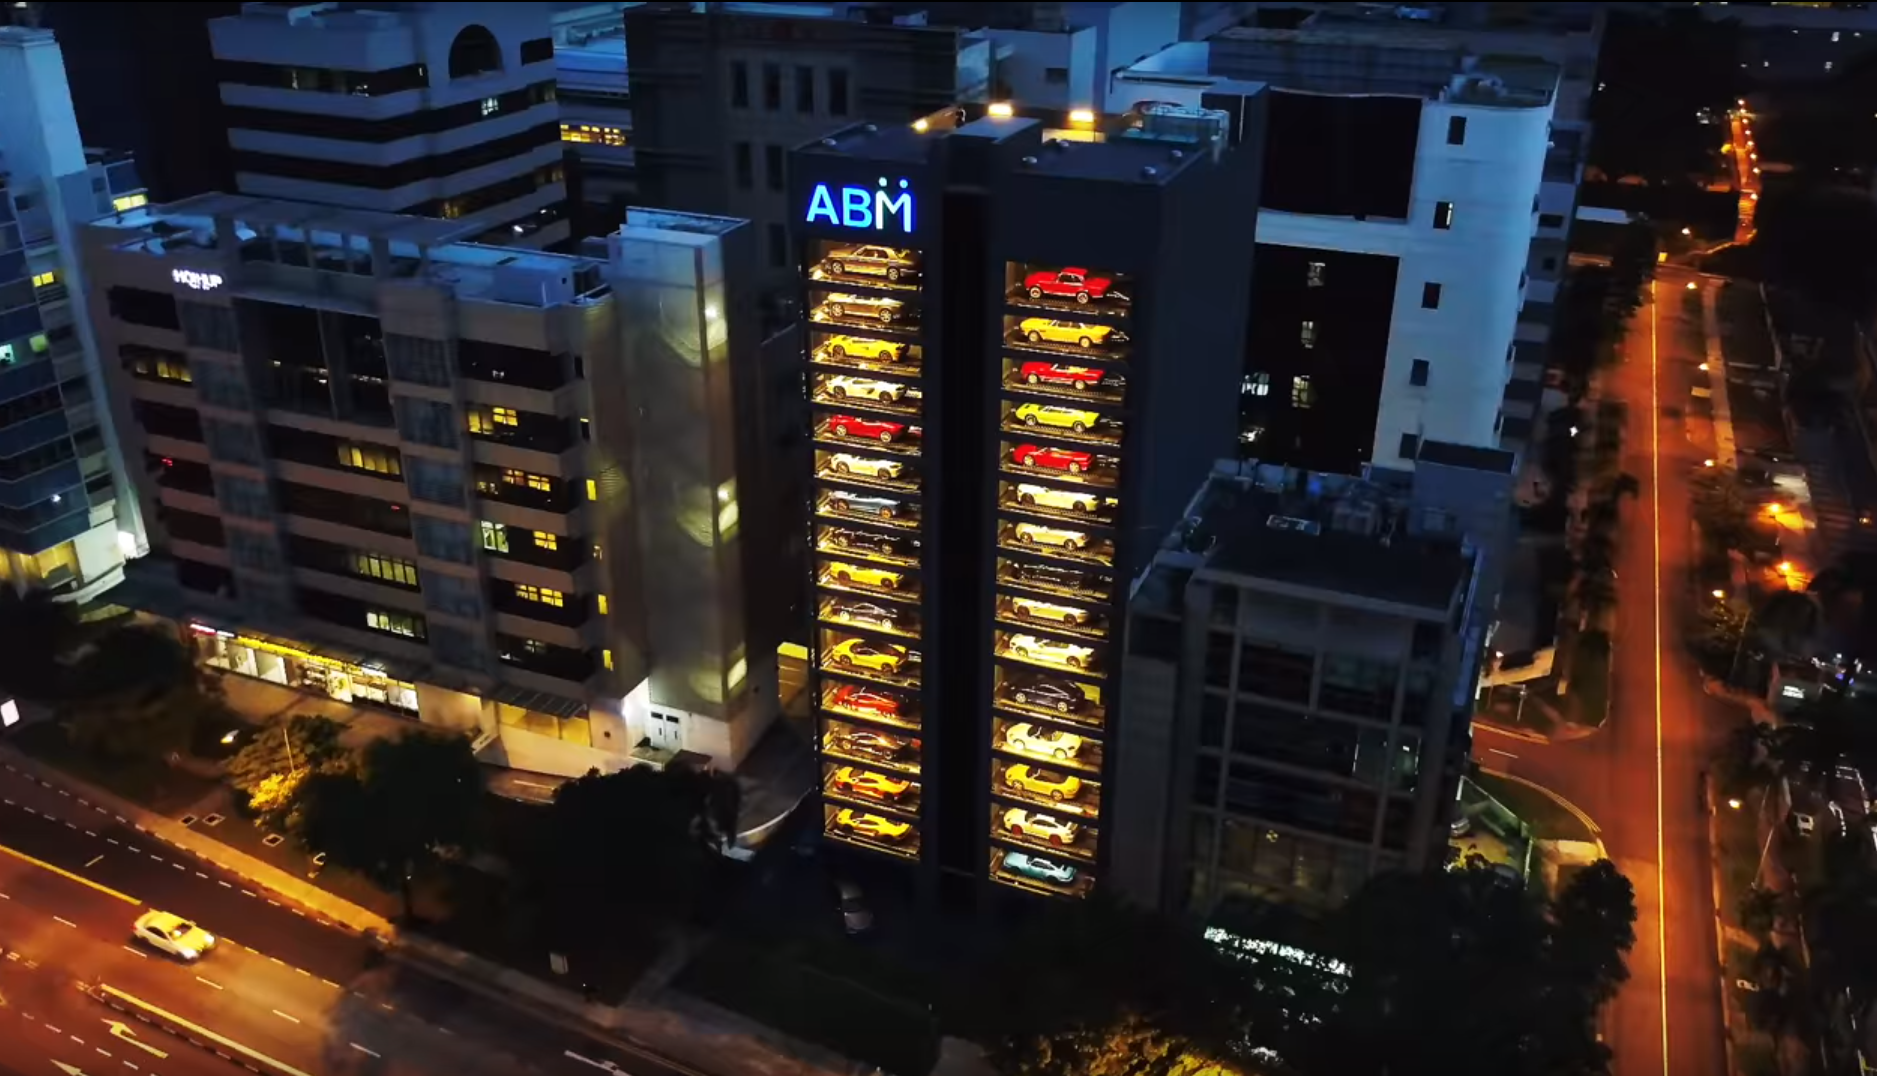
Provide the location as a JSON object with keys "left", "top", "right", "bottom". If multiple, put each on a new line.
{"left": 514, "top": 766, "right": 740, "bottom": 948}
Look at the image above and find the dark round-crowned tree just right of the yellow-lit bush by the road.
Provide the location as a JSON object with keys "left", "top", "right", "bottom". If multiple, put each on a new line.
{"left": 289, "top": 732, "right": 484, "bottom": 918}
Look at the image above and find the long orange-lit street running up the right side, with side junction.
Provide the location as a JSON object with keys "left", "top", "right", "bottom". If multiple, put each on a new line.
{"left": 1475, "top": 267, "right": 1732, "bottom": 1076}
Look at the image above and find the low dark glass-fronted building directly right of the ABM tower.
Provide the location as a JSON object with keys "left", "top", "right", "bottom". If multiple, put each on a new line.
{"left": 1111, "top": 441, "right": 1515, "bottom": 916}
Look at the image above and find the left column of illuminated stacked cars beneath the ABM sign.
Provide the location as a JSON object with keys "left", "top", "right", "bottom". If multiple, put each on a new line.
{"left": 800, "top": 214, "right": 927, "bottom": 858}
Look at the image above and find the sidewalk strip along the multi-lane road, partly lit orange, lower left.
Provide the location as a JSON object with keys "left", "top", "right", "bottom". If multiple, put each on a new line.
{"left": 0, "top": 743, "right": 863, "bottom": 1076}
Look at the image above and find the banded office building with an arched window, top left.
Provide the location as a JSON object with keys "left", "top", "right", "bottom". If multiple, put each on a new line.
{"left": 208, "top": 4, "right": 569, "bottom": 248}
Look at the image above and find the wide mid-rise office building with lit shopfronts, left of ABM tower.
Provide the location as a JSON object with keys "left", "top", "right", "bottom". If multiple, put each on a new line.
{"left": 84, "top": 193, "right": 775, "bottom": 776}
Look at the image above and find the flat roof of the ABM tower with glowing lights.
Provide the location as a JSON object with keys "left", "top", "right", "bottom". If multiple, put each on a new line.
{"left": 801, "top": 105, "right": 1228, "bottom": 186}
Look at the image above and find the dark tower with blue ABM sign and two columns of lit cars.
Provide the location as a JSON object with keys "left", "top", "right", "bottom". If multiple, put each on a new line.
{"left": 788, "top": 105, "right": 1258, "bottom": 903}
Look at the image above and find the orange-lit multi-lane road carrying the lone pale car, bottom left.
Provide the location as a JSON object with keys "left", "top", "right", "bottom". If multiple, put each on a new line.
{"left": 0, "top": 774, "right": 678, "bottom": 1076}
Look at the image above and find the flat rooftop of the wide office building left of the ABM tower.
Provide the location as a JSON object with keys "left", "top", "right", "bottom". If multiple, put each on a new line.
{"left": 92, "top": 193, "right": 597, "bottom": 306}
